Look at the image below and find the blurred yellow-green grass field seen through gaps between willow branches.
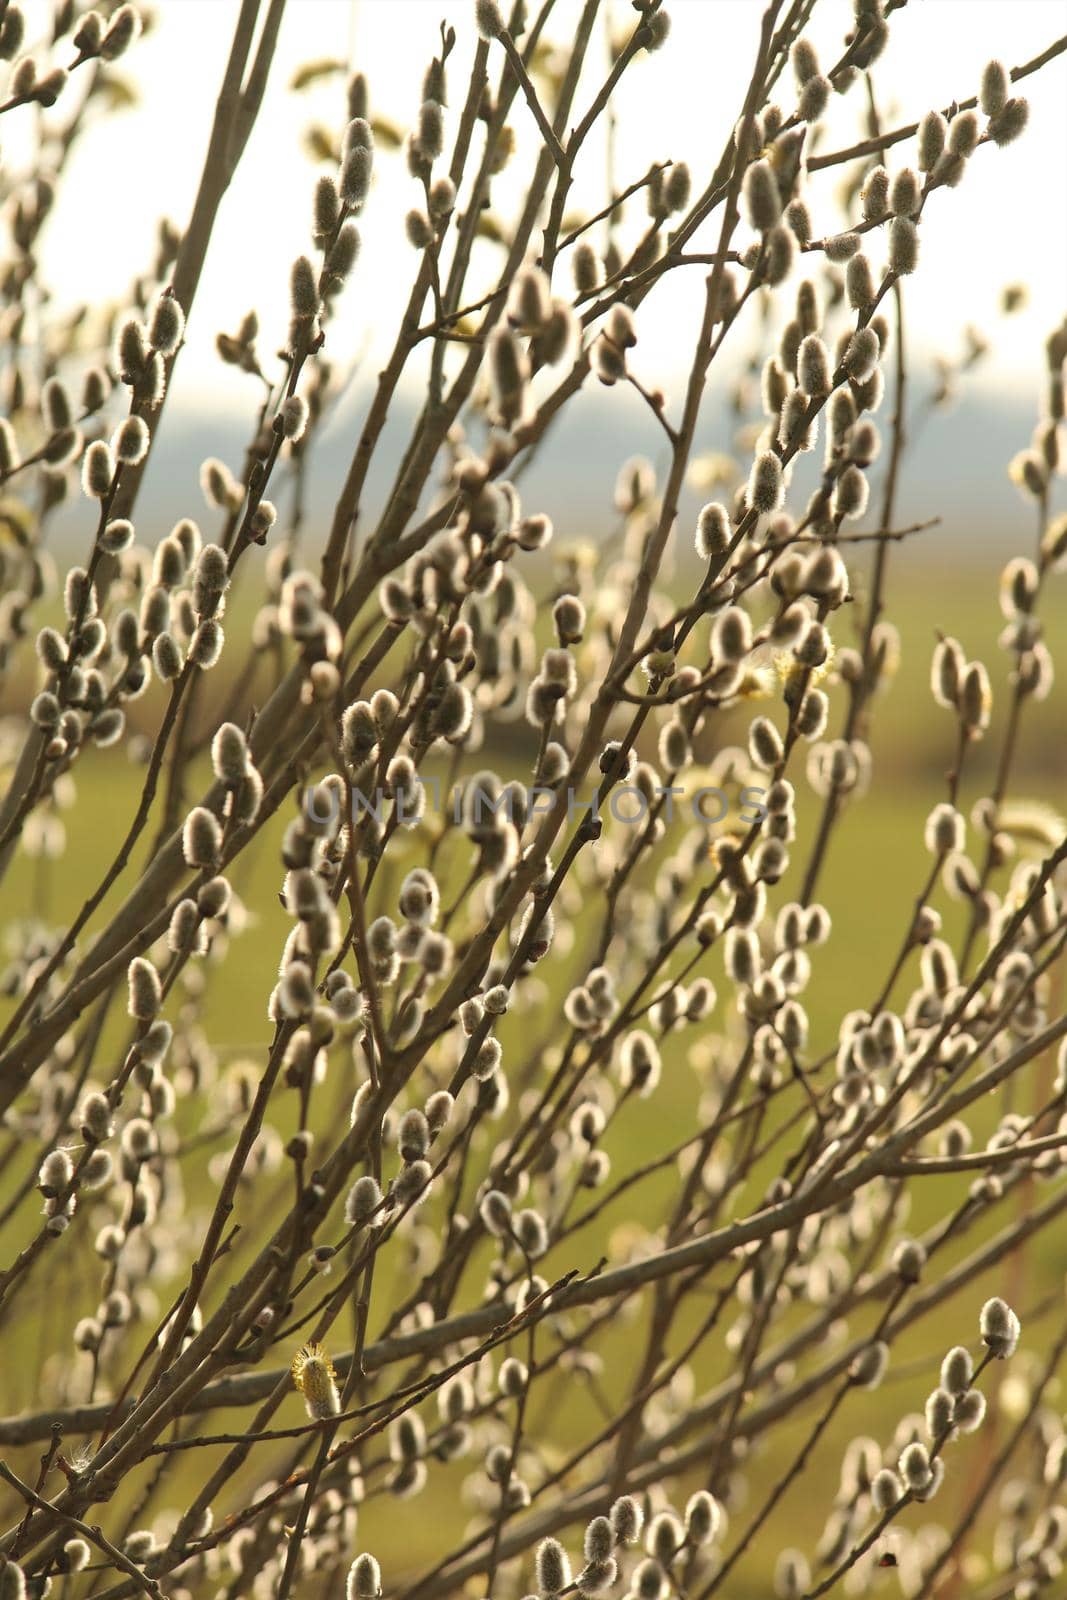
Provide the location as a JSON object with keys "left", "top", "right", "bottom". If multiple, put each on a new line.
{"left": 0, "top": 562, "right": 1067, "bottom": 1600}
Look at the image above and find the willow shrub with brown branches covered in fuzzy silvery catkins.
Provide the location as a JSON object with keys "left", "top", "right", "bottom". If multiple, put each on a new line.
{"left": 0, "top": 0, "right": 1067, "bottom": 1600}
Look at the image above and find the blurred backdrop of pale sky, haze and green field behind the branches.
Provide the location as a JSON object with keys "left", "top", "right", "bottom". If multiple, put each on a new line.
{"left": 0, "top": 0, "right": 1067, "bottom": 1600}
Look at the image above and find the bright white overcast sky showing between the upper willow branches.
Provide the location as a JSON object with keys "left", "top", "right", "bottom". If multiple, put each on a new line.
{"left": 16, "top": 0, "right": 1067, "bottom": 414}
